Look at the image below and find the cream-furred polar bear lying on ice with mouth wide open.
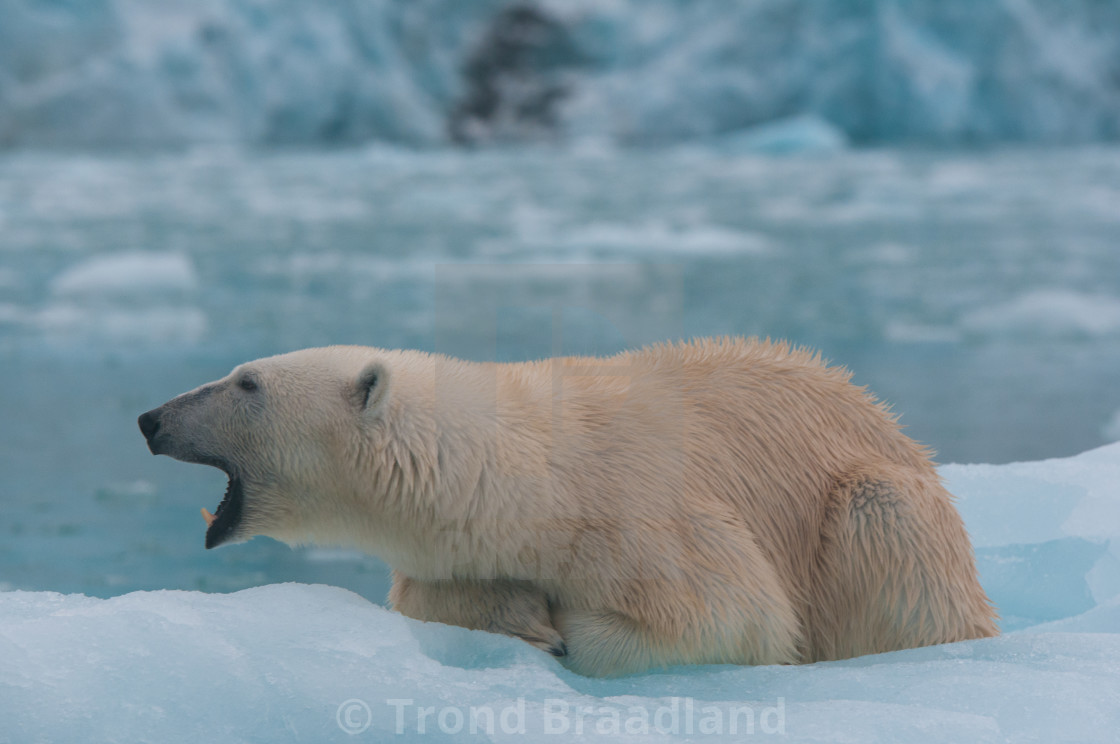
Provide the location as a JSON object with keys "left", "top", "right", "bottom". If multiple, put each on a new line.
{"left": 139, "top": 338, "right": 998, "bottom": 676}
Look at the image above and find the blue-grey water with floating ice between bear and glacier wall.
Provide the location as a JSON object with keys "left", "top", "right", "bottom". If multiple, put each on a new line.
{"left": 0, "top": 149, "right": 1120, "bottom": 601}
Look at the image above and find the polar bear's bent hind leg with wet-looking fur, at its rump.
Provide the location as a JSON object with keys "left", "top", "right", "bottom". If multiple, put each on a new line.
{"left": 809, "top": 464, "right": 999, "bottom": 661}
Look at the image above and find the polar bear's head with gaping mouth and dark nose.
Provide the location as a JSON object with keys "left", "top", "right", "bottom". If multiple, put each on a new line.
{"left": 139, "top": 346, "right": 392, "bottom": 548}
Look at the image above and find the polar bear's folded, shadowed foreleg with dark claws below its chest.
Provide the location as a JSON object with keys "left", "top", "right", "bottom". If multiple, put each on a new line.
{"left": 389, "top": 571, "right": 567, "bottom": 657}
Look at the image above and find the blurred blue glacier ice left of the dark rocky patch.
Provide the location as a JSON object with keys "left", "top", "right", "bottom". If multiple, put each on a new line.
{"left": 0, "top": 0, "right": 502, "bottom": 147}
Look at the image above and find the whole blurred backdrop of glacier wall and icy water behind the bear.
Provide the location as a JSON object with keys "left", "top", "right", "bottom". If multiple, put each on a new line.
{"left": 0, "top": 0, "right": 1120, "bottom": 601}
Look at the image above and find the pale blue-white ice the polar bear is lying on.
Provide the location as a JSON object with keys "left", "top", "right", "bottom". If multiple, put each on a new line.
{"left": 0, "top": 444, "right": 1120, "bottom": 742}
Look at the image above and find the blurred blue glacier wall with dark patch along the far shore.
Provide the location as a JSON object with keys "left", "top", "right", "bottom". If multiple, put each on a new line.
{"left": 0, "top": 0, "right": 1120, "bottom": 148}
